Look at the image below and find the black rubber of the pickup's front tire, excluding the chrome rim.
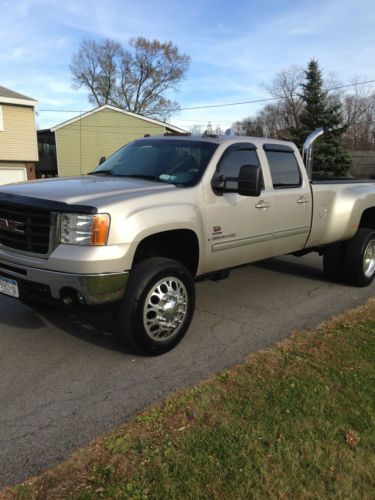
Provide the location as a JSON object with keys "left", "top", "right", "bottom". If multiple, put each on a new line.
{"left": 115, "top": 257, "right": 195, "bottom": 356}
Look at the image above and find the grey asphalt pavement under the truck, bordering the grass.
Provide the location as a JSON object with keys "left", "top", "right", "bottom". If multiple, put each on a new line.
{"left": 0, "top": 255, "right": 375, "bottom": 487}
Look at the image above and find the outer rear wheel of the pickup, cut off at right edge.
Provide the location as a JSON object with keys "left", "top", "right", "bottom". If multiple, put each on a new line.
{"left": 344, "top": 228, "right": 375, "bottom": 287}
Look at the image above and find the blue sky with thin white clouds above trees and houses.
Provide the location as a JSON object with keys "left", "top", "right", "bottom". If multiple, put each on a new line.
{"left": 0, "top": 0, "right": 375, "bottom": 128}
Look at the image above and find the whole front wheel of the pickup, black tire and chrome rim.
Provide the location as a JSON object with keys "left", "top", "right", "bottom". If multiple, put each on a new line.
{"left": 114, "top": 257, "right": 195, "bottom": 356}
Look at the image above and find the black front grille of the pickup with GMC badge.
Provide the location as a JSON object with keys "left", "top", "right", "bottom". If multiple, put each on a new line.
{"left": 0, "top": 202, "right": 51, "bottom": 254}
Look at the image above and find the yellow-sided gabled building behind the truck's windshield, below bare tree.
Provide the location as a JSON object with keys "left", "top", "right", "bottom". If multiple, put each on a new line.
{"left": 38, "top": 104, "right": 186, "bottom": 177}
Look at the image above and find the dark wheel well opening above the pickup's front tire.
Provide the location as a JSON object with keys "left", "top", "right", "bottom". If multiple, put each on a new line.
{"left": 133, "top": 229, "right": 199, "bottom": 276}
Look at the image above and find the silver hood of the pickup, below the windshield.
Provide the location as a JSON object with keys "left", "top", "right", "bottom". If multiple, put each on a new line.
{"left": 0, "top": 175, "right": 176, "bottom": 206}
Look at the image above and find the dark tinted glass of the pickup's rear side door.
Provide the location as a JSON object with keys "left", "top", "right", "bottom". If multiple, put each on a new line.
{"left": 265, "top": 151, "right": 301, "bottom": 188}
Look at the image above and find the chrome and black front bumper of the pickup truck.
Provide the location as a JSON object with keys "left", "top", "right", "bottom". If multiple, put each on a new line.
{"left": 0, "top": 259, "right": 129, "bottom": 305}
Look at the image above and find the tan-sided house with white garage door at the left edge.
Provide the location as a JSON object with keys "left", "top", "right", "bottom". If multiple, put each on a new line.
{"left": 0, "top": 86, "right": 38, "bottom": 185}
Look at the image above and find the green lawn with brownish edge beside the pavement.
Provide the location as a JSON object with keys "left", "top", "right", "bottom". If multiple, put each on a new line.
{"left": 0, "top": 300, "right": 375, "bottom": 499}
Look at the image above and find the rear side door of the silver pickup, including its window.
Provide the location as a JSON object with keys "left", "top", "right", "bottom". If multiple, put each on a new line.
{"left": 263, "top": 144, "right": 312, "bottom": 255}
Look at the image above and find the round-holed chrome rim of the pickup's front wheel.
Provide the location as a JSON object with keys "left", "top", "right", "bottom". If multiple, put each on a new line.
{"left": 143, "top": 277, "right": 188, "bottom": 342}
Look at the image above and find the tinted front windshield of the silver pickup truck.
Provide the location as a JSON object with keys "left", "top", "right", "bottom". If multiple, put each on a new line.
{"left": 91, "top": 139, "right": 218, "bottom": 186}
